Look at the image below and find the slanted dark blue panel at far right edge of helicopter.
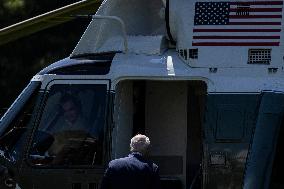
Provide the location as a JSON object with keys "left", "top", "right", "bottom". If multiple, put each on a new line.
{"left": 243, "top": 92, "right": 284, "bottom": 189}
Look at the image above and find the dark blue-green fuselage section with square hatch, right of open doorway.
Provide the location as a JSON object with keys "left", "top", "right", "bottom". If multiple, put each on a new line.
{"left": 202, "top": 93, "right": 261, "bottom": 189}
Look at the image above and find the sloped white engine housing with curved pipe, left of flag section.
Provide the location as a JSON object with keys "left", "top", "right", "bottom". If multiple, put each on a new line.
{"left": 72, "top": 0, "right": 167, "bottom": 56}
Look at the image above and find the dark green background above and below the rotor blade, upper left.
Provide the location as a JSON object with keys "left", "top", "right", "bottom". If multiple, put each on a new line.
{"left": 0, "top": 0, "right": 90, "bottom": 110}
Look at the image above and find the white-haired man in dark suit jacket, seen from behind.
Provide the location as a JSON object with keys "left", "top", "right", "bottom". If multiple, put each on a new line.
{"left": 101, "top": 134, "right": 160, "bottom": 189}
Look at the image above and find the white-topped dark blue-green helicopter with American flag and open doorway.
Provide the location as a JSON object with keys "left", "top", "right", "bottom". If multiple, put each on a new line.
{"left": 0, "top": 0, "right": 284, "bottom": 189}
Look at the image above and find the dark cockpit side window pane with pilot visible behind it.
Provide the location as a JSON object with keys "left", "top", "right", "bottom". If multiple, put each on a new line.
{"left": 29, "top": 84, "right": 107, "bottom": 166}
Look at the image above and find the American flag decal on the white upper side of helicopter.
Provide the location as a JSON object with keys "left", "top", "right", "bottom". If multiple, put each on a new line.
{"left": 192, "top": 0, "right": 283, "bottom": 46}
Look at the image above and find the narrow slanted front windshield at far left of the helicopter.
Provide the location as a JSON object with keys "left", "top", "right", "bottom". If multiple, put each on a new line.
{"left": 0, "top": 82, "right": 40, "bottom": 161}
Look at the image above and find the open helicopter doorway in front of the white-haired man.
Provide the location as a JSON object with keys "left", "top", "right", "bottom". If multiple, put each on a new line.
{"left": 112, "top": 80, "right": 207, "bottom": 189}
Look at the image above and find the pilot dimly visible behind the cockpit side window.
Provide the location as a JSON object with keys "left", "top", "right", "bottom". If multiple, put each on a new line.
{"left": 44, "top": 94, "right": 95, "bottom": 163}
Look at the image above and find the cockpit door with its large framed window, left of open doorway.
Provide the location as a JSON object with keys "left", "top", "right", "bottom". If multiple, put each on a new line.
{"left": 22, "top": 80, "right": 110, "bottom": 189}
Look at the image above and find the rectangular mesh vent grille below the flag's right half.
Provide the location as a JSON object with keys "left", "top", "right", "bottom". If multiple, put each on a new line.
{"left": 248, "top": 49, "right": 271, "bottom": 64}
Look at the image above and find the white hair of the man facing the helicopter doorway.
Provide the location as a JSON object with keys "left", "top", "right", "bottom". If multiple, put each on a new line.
{"left": 130, "top": 134, "right": 150, "bottom": 155}
